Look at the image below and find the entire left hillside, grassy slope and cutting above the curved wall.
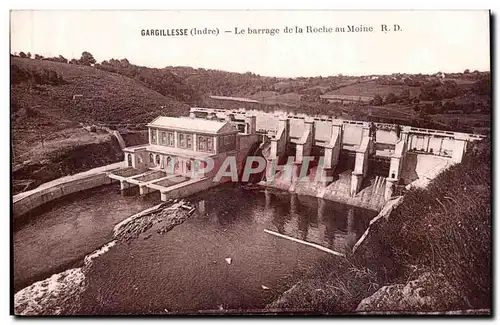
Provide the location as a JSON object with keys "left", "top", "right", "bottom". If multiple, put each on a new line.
{"left": 11, "top": 57, "right": 189, "bottom": 191}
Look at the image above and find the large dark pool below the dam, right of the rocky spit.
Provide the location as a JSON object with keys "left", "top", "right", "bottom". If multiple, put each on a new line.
{"left": 78, "top": 186, "right": 375, "bottom": 314}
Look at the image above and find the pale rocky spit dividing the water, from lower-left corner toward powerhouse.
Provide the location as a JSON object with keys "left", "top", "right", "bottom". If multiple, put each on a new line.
{"left": 14, "top": 200, "right": 194, "bottom": 316}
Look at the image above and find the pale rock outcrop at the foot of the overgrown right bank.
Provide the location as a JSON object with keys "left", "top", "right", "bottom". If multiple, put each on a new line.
{"left": 356, "top": 272, "right": 470, "bottom": 312}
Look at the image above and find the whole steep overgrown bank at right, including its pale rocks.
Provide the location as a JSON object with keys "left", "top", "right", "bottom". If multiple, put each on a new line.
{"left": 268, "top": 141, "right": 491, "bottom": 315}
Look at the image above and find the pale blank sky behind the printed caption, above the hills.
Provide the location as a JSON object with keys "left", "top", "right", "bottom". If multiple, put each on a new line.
{"left": 10, "top": 10, "right": 490, "bottom": 77}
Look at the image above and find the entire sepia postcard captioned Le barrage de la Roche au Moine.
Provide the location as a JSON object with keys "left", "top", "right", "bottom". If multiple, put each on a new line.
{"left": 10, "top": 10, "right": 492, "bottom": 316}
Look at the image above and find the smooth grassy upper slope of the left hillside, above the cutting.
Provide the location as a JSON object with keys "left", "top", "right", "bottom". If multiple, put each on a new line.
{"left": 11, "top": 58, "right": 188, "bottom": 123}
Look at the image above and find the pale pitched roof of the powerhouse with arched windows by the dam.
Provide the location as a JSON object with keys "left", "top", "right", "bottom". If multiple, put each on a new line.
{"left": 147, "top": 116, "right": 238, "bottom": 134}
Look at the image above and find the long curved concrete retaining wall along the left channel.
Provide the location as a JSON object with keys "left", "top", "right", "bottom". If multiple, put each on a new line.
{"left": 12, "top": 162, "right": 123, "bottom": 220}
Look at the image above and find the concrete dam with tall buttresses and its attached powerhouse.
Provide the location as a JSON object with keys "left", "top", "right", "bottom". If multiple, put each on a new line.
{"left": 108, "top": 107, "right": 484, "bottom": 210}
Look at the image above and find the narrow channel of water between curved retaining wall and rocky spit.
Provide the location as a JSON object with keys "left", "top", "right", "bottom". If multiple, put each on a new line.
{"left": 13, "top": 185, "right": 160, "bottom": 291}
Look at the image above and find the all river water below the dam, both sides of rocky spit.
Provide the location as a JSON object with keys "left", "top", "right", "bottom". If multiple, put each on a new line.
{"left": 14, "top": 185, "right": 376, "bottom": 314}
